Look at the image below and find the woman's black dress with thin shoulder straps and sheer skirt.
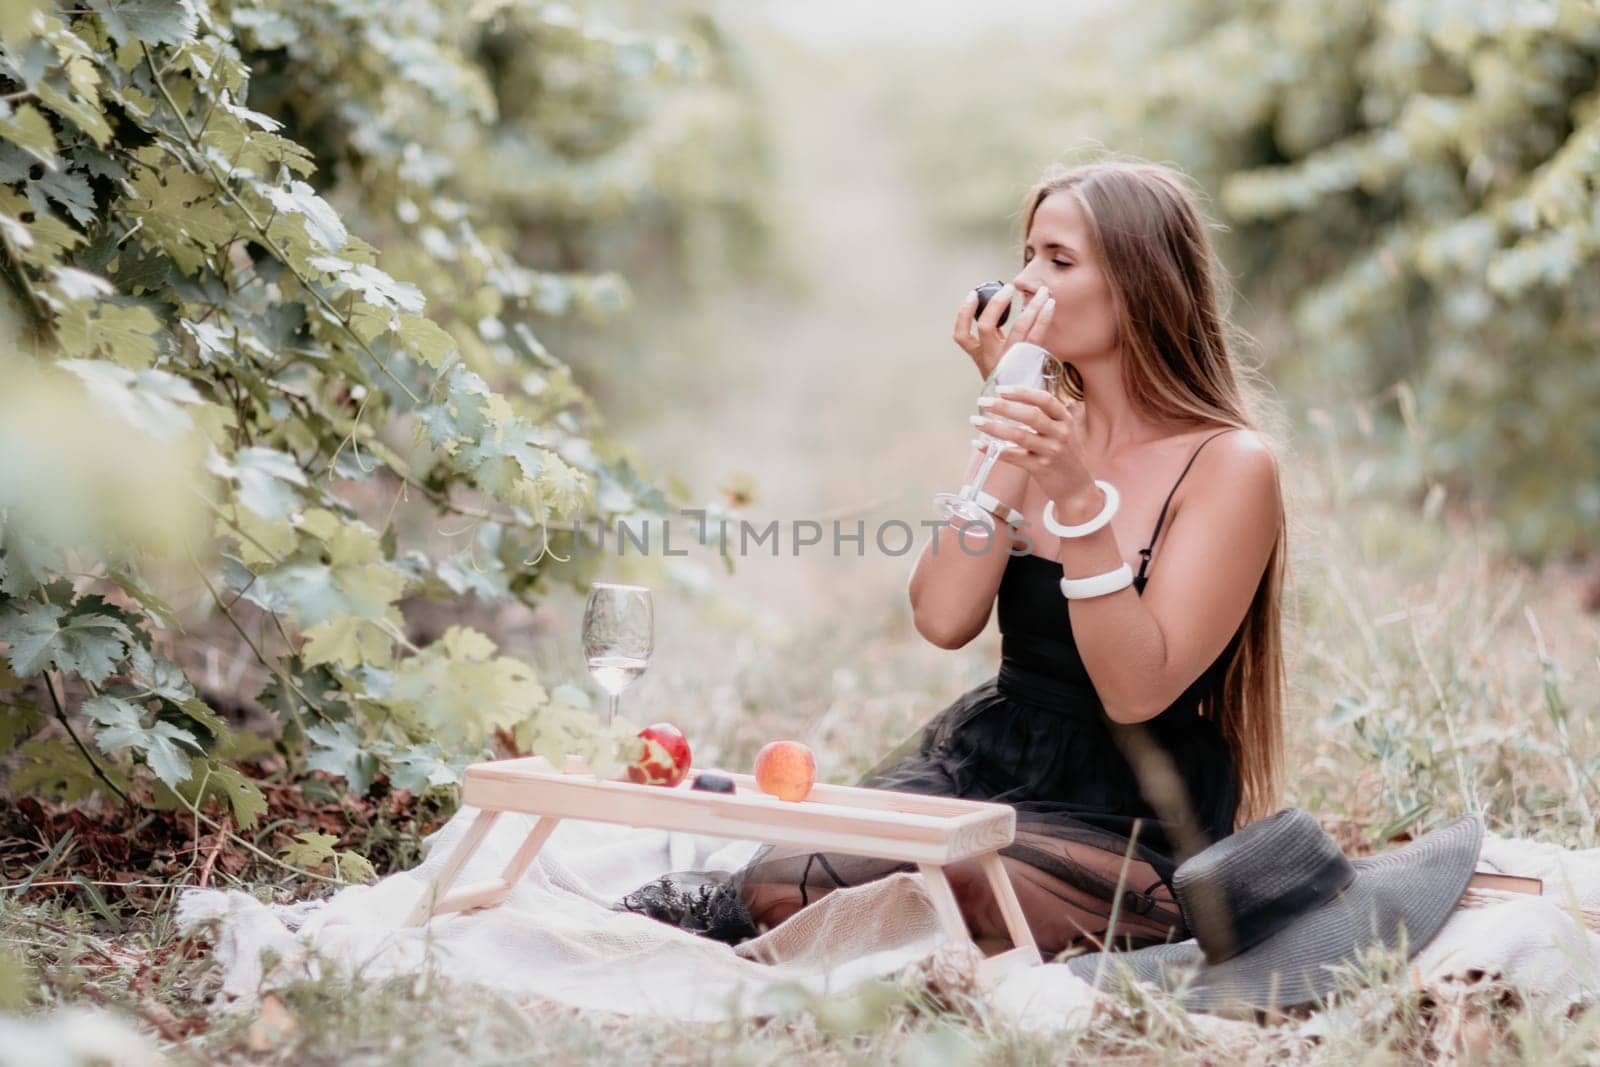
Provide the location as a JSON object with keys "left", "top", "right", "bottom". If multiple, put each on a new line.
{"left": 614, "top": 430, "right": 1243, "bottom": 958}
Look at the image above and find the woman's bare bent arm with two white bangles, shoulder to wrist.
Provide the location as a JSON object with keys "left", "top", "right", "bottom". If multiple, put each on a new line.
{"left": 1056, "top": 432, "right": 1283, "bottom": 723}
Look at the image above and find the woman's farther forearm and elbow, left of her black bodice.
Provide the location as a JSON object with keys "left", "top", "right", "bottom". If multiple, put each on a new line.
{"left": 906, "top": 448, "right": 1027, "bottom": 648}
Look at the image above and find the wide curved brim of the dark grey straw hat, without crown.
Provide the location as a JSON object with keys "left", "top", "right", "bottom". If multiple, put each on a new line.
{"left": 1066, "top": 814, "right": 1483, "bottom": 1011}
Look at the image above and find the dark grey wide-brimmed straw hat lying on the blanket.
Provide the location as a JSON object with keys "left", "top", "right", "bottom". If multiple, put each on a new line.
{"left": 1066, "top": 808, "right": 1483, "bottom": 1011}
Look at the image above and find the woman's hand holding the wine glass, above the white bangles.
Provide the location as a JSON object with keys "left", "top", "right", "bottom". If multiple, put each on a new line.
{"left": 973, "top": 386, "right": 1101, "bottom": 523}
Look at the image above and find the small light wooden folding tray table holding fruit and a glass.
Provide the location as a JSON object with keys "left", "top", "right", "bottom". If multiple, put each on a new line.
{"left": 408, "top": 757, "right": 1040, "bottom": 979}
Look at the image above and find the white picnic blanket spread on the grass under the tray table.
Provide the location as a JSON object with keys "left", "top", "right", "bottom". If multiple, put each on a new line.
{"left": 178, "top": 808, "right": 1600, "bottom": 1030}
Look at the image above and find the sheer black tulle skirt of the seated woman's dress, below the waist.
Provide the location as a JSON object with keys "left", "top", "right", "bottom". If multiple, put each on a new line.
{"left": 616, "top": 661, "right": 1237, "bottom": 958}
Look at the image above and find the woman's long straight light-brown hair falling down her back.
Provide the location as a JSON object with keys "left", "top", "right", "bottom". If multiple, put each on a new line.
{"left": 1022, "top": 158, "right": 1288, "bottom": 825}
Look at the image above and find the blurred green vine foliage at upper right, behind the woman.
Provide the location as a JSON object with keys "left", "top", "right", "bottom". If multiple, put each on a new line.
{"left": 920, "top": 0, "right": 1600, "bottom": 558}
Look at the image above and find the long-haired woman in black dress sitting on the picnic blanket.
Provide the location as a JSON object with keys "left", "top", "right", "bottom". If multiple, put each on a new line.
{"left": 618, "top": 160, "right": 1286, "bottom": 958}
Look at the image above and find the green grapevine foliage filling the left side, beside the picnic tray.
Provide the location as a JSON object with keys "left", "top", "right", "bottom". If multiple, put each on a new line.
{"left": 0, "top": 0, "right": 761, "bottom": 844}
